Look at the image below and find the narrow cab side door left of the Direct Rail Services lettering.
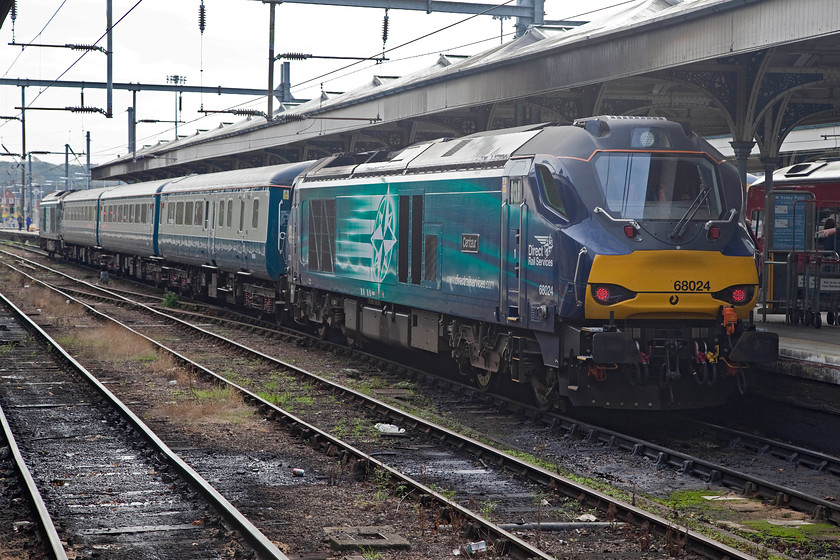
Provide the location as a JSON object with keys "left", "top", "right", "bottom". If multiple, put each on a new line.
{"left": 499, "top": 161, "right": 528, "bottom": 323}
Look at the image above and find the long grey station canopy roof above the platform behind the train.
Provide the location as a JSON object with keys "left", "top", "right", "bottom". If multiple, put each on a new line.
{"left": 93, "top": 0, "right": 840, "bottom": 181}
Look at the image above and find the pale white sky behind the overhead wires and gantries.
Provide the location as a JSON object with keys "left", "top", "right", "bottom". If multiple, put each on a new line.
{"left": 0, "top": 0, "right": 626, "bottom": 176}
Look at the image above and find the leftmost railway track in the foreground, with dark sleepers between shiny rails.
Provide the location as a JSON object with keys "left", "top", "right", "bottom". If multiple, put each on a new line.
{"left": 0, "top": 290, "right": 286, "bottom": 560}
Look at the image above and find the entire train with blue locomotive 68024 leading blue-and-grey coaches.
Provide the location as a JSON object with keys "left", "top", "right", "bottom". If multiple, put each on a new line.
{"left": 41, "top": 117, "right": 778, "bottom": 410}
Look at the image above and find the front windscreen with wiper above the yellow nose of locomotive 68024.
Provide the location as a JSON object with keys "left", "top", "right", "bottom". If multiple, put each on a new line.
{"left": 595, "top": 152, "right": 723, "bottom": 221}
